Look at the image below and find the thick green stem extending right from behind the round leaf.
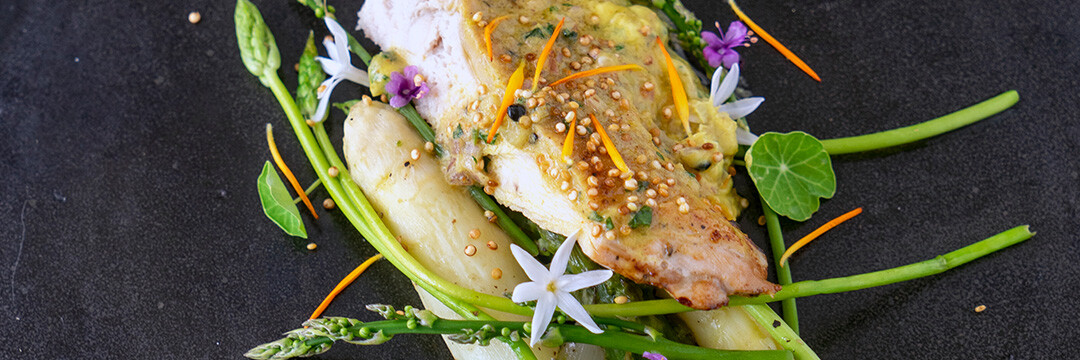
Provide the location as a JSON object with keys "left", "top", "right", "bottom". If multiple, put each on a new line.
{"left": 821, "top": 90, "right": 1020, "bottom": 155}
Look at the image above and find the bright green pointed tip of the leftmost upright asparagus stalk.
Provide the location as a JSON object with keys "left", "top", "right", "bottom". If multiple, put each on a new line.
{"left": 233, "top": 0, "right": 281, "bottom": 88}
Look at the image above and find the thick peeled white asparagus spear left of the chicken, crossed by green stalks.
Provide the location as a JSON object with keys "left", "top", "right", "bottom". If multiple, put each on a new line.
{"left": 343, "top": 102, "right": 603, "bottom": 359}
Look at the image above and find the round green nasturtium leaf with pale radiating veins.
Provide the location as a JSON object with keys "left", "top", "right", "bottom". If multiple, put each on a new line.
{"left": 745, "top": 131, "right": 836, "bottom": 222}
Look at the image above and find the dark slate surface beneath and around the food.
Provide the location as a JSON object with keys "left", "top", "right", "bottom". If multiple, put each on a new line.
{"left": 0, "top": 0, "right": 1080, "bottom": 359}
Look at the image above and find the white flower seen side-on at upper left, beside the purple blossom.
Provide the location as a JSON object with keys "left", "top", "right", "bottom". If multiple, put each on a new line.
{"left": 311, "top": 16, "right": 368, "bottom": 122}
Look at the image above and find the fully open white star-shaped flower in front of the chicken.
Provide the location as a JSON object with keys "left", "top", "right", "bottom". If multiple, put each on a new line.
{"left": 510, "top": 230, "right": 611, "bottom": 345}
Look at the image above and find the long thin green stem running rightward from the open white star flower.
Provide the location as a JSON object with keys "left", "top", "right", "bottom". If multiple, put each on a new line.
{"left": 585, "top": 225, "right": 1035, "bottom": 317}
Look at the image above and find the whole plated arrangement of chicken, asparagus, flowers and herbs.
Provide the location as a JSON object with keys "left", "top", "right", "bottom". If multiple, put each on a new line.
{"left": 235, "top": 0, "right": 1031, "bottom": 359}
